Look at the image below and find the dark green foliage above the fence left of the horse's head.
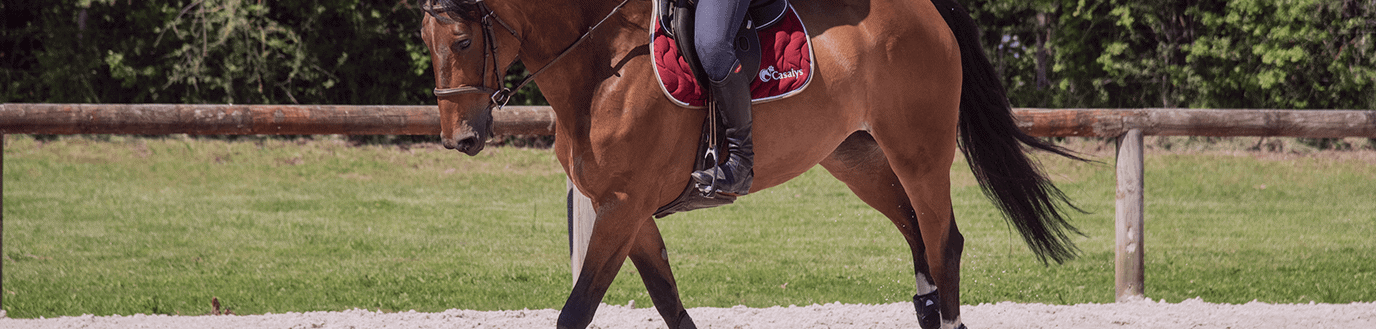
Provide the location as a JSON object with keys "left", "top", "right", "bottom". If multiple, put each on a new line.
{"left": 0, "top": 0, "right": 433, "bottom": 105}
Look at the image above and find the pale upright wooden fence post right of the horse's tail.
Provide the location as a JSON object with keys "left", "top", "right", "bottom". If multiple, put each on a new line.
{"left": 1113, "top": 129, "right": 1145, "bottom": 303}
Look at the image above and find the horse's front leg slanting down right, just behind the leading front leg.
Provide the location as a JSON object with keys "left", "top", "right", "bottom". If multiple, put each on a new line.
{"left": 629, "top": 219, "right": 696, "bottom": 329}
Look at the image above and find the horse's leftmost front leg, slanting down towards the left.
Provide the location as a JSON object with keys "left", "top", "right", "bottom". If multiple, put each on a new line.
{"left": 557, "top": 193, "right": 658, "bottom": 329}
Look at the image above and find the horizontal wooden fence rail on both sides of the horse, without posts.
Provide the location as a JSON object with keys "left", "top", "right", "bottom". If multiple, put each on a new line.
{"left": 10, "top": 103, "right": 1376, "bottom": 138}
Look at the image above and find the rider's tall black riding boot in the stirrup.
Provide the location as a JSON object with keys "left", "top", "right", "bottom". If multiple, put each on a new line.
{"left": 692, "top": 65, "right": 755, "bottom": 195}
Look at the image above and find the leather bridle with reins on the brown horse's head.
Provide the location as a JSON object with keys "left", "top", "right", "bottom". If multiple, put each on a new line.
{"left": 421, "top": 0, "right": 630, "bottom": 109}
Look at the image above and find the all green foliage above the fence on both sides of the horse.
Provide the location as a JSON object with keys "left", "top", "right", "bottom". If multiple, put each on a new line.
{"left": 0, "top": 0, "right": 1376, "bottom": 109}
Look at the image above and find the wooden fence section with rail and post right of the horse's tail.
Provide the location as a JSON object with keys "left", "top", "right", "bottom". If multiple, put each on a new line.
{"left": 1014, "top": 109, "right": 1376, "bottom": 301}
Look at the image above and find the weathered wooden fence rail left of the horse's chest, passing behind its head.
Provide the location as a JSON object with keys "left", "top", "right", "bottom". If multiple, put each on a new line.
{"left": 0, "top": 103, "right": 555, "bottom": 135}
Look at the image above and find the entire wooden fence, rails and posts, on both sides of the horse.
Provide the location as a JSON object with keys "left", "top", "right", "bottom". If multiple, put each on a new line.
{"left": 0, "top": 103, "right": 1376, "bottom": 306}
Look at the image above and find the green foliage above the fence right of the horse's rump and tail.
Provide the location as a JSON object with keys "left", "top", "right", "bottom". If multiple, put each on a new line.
{"left": 970, "top": 0, "right": 1376, "bottom": 109}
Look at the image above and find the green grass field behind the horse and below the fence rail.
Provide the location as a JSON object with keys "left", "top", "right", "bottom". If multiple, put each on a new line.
{"left": 0, "top": 135, "right": 1376, "bottom": 318}
